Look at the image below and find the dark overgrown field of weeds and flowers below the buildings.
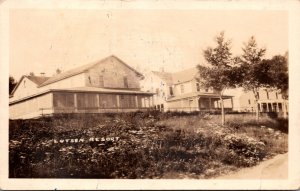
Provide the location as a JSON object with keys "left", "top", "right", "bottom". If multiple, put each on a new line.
{"left": 9, "top": 111, "right": 288, "bottom": 178}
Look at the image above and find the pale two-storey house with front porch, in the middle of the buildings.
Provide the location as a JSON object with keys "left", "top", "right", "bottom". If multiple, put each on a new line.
{"left": 142, "top": 68, "right": 233, "bottom": 112}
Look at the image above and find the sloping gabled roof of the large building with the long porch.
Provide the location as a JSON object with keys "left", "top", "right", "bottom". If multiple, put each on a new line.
{"left": 39, "top": 55, "right": 143, "bottom": 87}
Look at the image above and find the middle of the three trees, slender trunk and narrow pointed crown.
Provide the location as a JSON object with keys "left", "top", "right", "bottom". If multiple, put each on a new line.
{"left": 239, "top": 36, "right": 271, "bottom": 120}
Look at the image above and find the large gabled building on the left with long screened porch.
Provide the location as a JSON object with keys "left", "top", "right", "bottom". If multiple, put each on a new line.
{"left": 9, "top": 56, "right": 153, "bottom": 119}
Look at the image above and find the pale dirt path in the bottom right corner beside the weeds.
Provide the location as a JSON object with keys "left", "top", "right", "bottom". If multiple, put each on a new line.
{"left": 216, "top": 153, "right": 288, "bottom": 179}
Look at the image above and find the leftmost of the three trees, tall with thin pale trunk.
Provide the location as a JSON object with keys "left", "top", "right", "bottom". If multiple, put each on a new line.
{"left": 197, "top": 32, "right": 234, "bottom": 125}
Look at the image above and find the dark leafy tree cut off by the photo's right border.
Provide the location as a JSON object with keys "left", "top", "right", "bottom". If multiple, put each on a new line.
{"left": 266, "top": 54, "right": 289, "bottom": 118}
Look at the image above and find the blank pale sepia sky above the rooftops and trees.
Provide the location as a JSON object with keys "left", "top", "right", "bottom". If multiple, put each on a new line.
{"left": 9, "top": 9, "right": 288, "bottom": 80}
